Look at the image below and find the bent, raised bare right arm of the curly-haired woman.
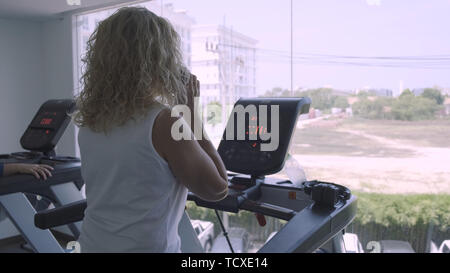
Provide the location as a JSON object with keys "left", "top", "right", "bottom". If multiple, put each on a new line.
{"left": 152, "top": 75, "right": 228, "bottom": 201}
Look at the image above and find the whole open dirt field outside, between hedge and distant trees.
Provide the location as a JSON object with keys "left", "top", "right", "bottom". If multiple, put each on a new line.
{"left": 208, "top": 115, "right": 450, "bottom": 194}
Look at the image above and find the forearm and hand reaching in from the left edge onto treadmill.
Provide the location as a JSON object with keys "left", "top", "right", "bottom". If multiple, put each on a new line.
{"left": 0, "top": 163, "right": 53, "bottom": 180}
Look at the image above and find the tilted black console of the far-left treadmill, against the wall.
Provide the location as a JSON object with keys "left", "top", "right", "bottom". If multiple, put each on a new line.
{"left": 20, "top": 99, "right": 75, "bottom": 154}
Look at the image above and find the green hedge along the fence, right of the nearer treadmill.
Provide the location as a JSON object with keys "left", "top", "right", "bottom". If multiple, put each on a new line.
{"left": 354, "top": 190, "right": 450, "bottom": 252}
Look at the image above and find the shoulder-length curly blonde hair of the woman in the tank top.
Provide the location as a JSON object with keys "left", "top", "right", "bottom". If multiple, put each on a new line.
{"left": 74, "top": 7, "right": 187, "bottom": 133}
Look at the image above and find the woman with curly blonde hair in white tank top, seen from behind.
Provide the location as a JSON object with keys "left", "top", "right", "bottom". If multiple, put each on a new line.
{"left": 75, "top": 8, "right": 228, "bottom": 252}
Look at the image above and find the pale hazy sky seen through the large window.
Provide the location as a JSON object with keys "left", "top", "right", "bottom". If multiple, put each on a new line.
{"left": 165, "top": 0, "right": 450, "bottom": 92}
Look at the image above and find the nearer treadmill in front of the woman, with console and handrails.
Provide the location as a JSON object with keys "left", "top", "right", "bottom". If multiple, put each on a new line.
{"left": 35, "top": 98, "right": 357, "bottom": 253}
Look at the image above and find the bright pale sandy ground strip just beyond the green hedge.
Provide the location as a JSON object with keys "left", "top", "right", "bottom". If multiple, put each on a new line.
{"left": 294, "top": 120, "right": 450, "bottom": 194}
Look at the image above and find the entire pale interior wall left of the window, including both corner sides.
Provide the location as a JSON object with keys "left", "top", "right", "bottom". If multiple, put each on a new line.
{"left": 0, "top": 16, "right": 75, "bottom": 156}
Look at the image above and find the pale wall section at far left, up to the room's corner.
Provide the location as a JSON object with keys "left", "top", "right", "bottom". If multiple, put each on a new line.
{"left": 0, "top": 19, "right": 46, "bottom": 153}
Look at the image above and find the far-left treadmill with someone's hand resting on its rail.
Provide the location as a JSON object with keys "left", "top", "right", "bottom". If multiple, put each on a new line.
{"left": 0, "top": 100, "right": 83, "bottom": 252}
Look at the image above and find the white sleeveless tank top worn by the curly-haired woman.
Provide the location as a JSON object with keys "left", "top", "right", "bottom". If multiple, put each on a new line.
{"left": 78, "top": 104, "right": 187, "bottom": 252}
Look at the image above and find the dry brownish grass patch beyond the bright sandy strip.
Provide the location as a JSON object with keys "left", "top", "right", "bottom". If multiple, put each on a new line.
{"left": 291, "top": 118, "right": 450, "bottom": 158}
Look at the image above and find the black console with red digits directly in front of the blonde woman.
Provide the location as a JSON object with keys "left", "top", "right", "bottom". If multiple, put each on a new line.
{"left": 218, "top": 97, "right": 311, "bottom": 177}
